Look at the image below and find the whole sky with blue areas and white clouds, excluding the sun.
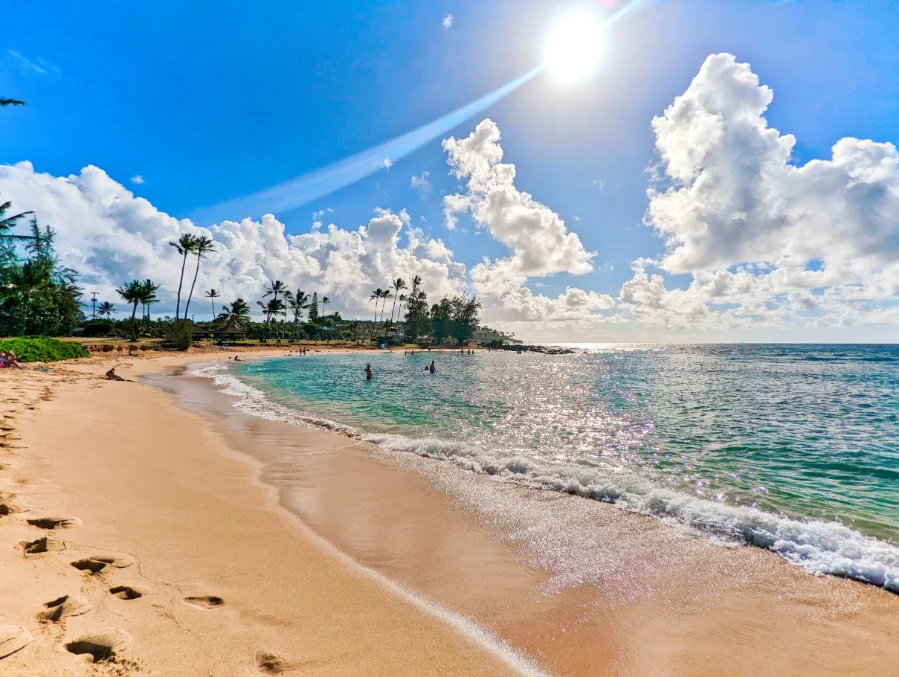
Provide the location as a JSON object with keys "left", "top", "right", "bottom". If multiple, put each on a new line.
{"left": 0, "top": 0, "right": 899, "bottom": 342}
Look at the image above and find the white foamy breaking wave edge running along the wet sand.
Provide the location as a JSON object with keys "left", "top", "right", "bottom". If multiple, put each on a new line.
{"left": 192, "top": 365, "right": 899, "bottom": 593}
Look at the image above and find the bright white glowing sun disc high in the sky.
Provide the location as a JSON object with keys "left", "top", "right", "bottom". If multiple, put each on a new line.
{"left": 543, "top": 11, "right": 603, "bottom": 82}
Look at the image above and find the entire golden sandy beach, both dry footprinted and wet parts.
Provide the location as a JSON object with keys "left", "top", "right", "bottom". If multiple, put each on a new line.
{"left": 0, "top": 351, "right": 899, "bottom": 676}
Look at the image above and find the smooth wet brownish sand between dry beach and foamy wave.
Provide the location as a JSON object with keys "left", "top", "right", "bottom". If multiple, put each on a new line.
{"left": 155, "top": 356, "right": 899, "bottom": 675}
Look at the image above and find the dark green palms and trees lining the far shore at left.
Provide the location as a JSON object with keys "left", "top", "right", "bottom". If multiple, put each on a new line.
{"left": 0, "top": 144, "right": 492, "bottom": 344}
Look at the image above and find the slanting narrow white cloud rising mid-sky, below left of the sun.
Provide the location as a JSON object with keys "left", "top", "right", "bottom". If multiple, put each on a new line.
{"left": 443, "top": 118, "right": 595, "bottom": 277}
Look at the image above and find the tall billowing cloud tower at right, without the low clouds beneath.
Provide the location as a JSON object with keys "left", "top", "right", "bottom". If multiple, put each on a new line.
{"left": 647, "top": 54, "right": 899, "bottom": 273}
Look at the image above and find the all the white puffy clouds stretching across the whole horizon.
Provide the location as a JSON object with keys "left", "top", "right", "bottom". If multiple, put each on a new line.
{"left": 0, "top": 54, "right": 899, "bottom": 340}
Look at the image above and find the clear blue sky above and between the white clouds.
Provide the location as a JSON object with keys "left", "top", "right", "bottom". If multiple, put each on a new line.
{"left": 0, "top": 0, "right": 899, "bottom": 338}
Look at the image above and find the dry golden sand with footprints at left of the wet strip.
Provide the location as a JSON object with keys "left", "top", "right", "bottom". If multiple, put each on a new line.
{"left": 0, "top": 357, "right": 532, "bottom": 677}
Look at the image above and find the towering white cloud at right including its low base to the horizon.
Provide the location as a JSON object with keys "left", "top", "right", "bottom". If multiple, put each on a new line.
{"left": 620, "top": 54, "right": 899, "bottom": 329}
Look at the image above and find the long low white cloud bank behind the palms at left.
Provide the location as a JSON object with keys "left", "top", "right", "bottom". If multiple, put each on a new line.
{"left": 0, "top": 162, "right": 466, "bottom": 316}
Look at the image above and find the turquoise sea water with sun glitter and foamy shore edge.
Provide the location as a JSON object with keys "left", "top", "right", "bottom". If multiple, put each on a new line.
{"left": 223, "top": 345, "right": 899, "bottom": 587}
